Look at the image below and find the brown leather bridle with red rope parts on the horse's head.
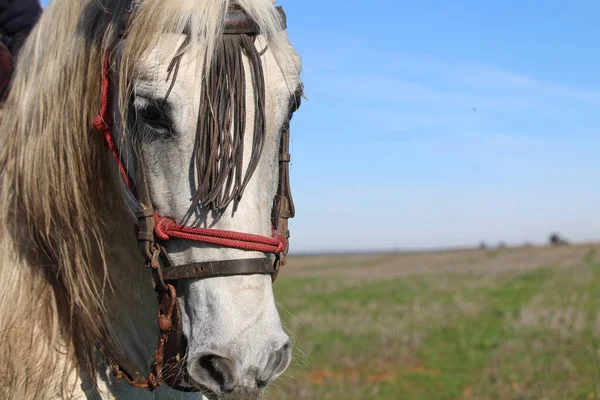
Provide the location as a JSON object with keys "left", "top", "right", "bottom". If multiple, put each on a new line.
{"left": 94, "top": 6, "right": 300, "bottom": 392}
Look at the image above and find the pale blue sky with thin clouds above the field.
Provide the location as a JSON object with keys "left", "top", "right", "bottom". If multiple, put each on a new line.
{"left": 41, "top": 0, "right": 600, "bottom": 252}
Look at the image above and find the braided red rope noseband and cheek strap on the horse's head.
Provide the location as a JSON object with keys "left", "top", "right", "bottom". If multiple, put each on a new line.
{"left": 94, "top": 56, "right": 288, "bottom": 254}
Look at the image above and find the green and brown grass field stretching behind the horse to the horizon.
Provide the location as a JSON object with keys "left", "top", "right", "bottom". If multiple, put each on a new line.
{"left": 265, "top": 244, "right": 600, "bottom": 400}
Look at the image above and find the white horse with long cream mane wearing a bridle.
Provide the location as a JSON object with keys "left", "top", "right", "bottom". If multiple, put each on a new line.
{"left": 0, "top": 0, "right": 304, "bottom": 400}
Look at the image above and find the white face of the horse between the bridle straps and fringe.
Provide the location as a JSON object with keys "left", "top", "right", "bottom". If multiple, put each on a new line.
{"left": 113, "top": 34, "right": 299, "bottom": 397}
